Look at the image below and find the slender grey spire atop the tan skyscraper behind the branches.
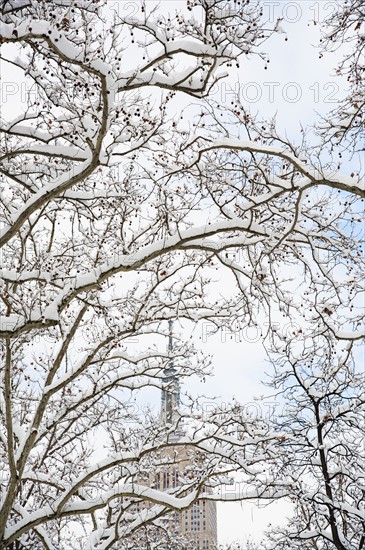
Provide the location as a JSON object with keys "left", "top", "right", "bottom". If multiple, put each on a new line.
{"left": 161, "top": 320, "right": 180, "bottom": 427}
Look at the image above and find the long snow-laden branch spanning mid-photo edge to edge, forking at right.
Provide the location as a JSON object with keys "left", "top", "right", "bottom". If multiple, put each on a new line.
{"left": 0, "top": 128, "right": 364, "bottom": 339}
